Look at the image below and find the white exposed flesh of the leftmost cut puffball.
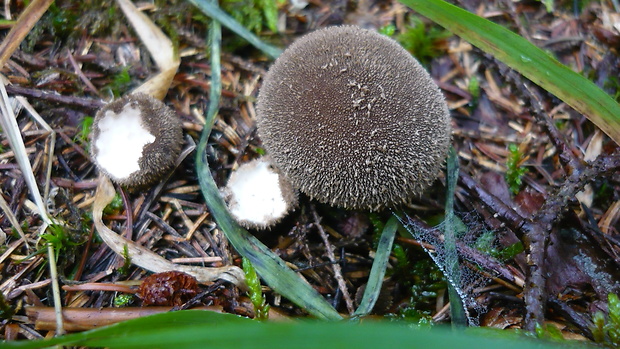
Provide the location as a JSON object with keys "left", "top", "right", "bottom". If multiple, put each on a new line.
{"left": 95, "top": 104, "right": 155, "bottom": 179}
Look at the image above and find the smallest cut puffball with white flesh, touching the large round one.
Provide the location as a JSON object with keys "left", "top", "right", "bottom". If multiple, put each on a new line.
{"left": 223, "top": 157, "right": 297, "bottom": 229}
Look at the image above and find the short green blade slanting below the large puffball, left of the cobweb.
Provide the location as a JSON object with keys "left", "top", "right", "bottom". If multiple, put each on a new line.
{"left": 353, "top": 216, "right": 398, "bottom": 316}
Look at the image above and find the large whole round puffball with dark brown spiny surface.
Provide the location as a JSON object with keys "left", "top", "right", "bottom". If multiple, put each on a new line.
{"left": 257, "top": 26, "right": 451, "bottom": 210}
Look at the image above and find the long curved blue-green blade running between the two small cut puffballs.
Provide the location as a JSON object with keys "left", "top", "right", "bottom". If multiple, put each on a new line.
{"left": 196, "top": 20, "right": 342, "bottom": 320}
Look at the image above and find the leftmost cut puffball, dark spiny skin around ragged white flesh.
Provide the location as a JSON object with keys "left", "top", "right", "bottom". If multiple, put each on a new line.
{"left": 91, "top": 93, "right": 183, "bottom": 187}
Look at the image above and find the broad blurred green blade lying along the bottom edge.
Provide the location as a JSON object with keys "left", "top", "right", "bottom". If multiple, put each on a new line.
{"left": 0, "top": 310, "right": 585, "bottom": 349}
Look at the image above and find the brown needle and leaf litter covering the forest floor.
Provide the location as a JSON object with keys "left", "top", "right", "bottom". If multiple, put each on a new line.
{"left": 0, "top": 0, "right": 620, "bottom": 339}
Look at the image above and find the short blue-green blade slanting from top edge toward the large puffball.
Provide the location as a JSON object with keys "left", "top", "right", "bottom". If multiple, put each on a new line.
{"left": 188, "top": 0, "right": 282, "bottom": 58}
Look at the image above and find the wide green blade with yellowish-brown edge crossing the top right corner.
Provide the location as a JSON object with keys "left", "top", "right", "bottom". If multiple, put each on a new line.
{"left": 400, "top": 0, "right": 620, "bottom": 144}
